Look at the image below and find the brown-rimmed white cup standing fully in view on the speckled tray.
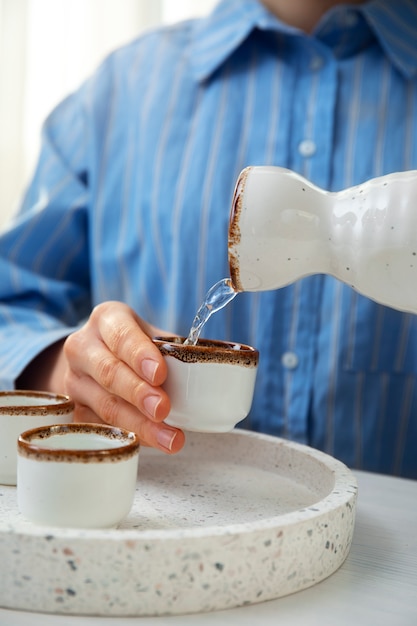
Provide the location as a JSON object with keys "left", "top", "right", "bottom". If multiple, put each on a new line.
{"left": 17, "top": 423, "right": 139, "bottom": 528}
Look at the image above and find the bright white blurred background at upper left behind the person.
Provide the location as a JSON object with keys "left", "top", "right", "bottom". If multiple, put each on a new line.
{"left": 0, "top": 0, "right": 217, "bottom": 228}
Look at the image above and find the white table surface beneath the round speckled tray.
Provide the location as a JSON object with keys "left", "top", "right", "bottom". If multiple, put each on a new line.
{"left": 0, "top": 472, "right": 417, "bottom": 626}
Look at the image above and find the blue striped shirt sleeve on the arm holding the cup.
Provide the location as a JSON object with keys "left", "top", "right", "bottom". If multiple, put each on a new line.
{"left": 0, "top": 83, "right": 91, "bottom": 389}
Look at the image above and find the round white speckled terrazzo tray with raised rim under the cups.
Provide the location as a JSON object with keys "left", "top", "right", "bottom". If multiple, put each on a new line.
{"left": 0, "top": 431, "right": 357, "bottom": 616}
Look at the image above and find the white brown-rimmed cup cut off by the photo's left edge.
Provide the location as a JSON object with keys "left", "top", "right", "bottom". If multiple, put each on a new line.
{"left": 0, "top": 390, "right": 74, "bottom": 485}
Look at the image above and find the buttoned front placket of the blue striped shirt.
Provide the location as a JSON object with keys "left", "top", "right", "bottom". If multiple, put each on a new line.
{"left": 277, "top": 39, "right": 337, "bottom": 442}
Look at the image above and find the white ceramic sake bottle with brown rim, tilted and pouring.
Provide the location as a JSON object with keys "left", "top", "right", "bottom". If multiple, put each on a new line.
{"left": 228, "top": 166, "right": 417, "bottom": 312}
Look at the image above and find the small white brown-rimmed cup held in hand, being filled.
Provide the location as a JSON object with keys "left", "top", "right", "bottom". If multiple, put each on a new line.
{"left": 153, "top": 337, "right": 259, "bottom": 433}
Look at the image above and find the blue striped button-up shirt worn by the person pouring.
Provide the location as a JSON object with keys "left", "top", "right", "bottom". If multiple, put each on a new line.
{"left": 0, "top": 0, "right": 417, "bottom": 478}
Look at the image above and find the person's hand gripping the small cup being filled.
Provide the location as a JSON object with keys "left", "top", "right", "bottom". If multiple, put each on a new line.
{"left": 63, "top": 302, "right": 185, "bottom": 453}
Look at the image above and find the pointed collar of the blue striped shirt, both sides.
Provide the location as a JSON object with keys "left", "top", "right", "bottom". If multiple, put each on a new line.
{"left": 190, "top": 0, "right": 417, "bottom": 81}
